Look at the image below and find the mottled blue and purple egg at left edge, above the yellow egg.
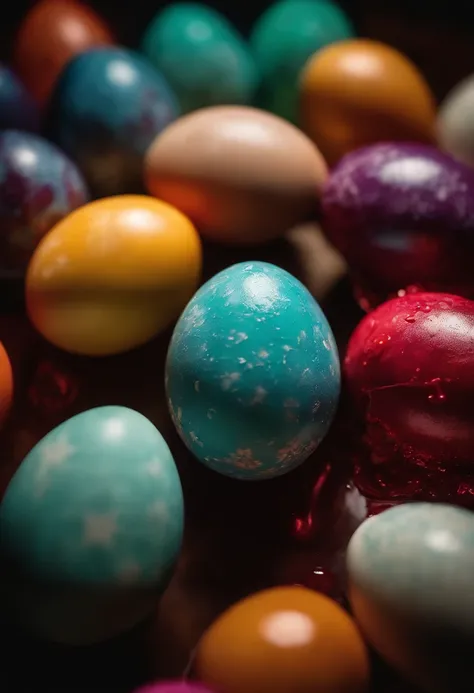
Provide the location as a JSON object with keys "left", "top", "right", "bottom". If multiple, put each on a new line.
{"left": 0, "top": 130, "right": 88, "bottom": 274}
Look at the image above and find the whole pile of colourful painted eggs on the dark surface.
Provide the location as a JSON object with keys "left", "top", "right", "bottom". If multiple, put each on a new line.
{"left": 0, "top": 0, "right": 474, "bottom": 693}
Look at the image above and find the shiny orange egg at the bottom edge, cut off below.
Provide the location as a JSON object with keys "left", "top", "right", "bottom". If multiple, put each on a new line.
{"left": 195, "top": 587, "right": 369, "bottom": 693}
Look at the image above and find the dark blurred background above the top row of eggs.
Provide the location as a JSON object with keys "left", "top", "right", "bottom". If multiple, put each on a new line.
{"left": 0, "top": 0, "right": 474, "bottom": 98}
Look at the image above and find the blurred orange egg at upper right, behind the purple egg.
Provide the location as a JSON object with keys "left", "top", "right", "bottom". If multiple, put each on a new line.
{"left": 300, "top": 39, "right": 436, "bottom": 165}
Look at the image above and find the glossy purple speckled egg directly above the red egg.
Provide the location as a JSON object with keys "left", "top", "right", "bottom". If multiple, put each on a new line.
{"left": 322, "top": 143, "right": 474, "bottom": 310}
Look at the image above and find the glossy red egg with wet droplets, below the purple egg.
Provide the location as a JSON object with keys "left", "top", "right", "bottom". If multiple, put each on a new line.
{"left": 344, "top": 293, "right": 474, "bottom": 503}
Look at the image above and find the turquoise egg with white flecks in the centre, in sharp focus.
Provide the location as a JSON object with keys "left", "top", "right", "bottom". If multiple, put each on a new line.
{"left": 166, "top": 262, "right": 340, "bottom": 479}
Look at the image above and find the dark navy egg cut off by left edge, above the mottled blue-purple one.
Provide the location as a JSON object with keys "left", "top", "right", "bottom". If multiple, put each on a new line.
{"left": 0, "top": 63, "right": 40, "bottom": 132}
